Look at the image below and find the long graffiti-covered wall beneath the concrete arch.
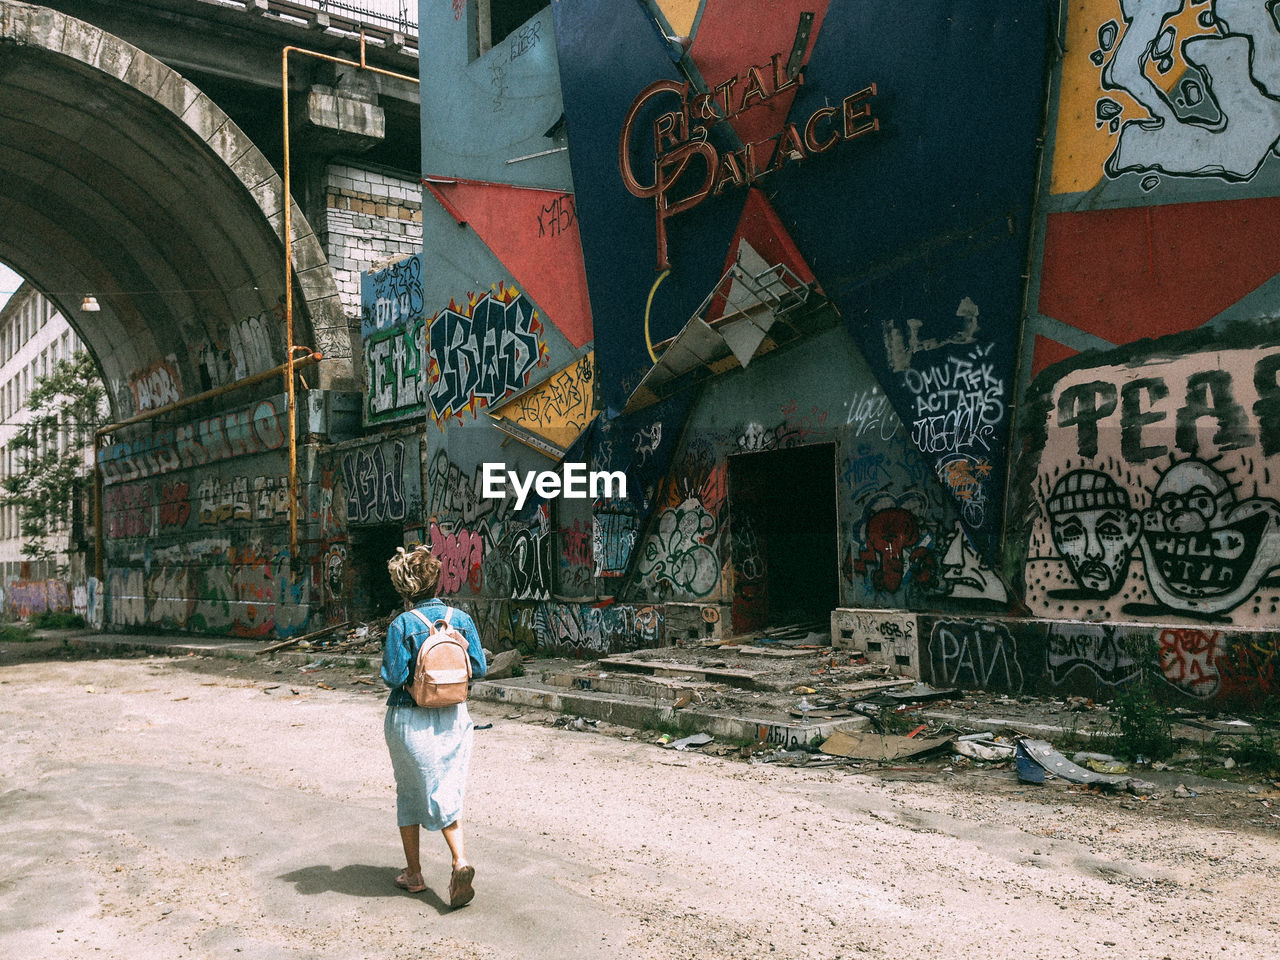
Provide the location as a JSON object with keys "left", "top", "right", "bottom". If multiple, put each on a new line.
{"left": 99, "top": 394, "right": 360, "bottom": 637}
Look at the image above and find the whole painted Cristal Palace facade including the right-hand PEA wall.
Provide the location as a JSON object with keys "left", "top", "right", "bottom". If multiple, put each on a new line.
{"left": 386, "top": 0, "right": 1280, "bottom": 716}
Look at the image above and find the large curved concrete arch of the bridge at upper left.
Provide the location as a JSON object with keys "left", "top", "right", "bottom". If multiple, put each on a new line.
{"left": 0, "top": 0, "right": 358, "bottom": 417}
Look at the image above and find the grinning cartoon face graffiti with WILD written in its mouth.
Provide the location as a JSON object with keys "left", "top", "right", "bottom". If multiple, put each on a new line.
{"left": 1142, "top": 460, "right": 1280, "bottom": 613}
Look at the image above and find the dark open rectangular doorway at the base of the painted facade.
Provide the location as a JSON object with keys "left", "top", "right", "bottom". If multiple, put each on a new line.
{"left": 728, "top": 443, "right": 840, "bottom": 634}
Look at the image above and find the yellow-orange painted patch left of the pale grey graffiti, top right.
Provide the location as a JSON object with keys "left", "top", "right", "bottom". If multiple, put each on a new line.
{"left": 1050, "top": 0, "right": 1151, "bottom": 193}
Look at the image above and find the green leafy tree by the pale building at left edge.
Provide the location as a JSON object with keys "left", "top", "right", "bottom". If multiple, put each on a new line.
{"left": 0, "top": 351, "right": 106, "bottom": 561}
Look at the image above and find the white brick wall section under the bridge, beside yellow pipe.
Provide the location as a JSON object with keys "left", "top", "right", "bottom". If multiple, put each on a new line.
{"left": 320, "top": 164, "right": 422, "bottom": 317}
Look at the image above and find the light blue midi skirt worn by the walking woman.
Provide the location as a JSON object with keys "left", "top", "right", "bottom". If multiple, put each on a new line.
{"left": 383, "top": 704, "right": 474, "bottom": 829}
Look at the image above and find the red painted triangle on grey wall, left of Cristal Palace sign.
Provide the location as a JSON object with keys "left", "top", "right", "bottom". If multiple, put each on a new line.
{"left": 424, "top": 178, "right": 593, "bottom": 349}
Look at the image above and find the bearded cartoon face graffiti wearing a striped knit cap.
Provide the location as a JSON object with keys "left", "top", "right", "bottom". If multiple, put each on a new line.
{"left": 1047, "top": 470, "right": 1142, "bottom": 596}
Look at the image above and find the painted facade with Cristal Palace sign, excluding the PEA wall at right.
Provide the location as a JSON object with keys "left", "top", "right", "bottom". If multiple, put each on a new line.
{"left": 391, "top": 0, "right": 1048, "bottom": 650}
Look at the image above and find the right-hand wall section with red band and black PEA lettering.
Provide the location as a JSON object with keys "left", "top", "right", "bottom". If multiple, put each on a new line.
{"left": 1007, "top": 0, "right": 1280, "bottom": 640}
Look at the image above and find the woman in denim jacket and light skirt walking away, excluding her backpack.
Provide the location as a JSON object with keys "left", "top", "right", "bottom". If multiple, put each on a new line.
{"left": 383, "top": 547, "right": 488, "bottom": 906}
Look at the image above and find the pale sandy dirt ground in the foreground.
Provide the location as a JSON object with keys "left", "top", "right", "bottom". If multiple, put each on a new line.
{"left": 0, "top": 643, "right": 1280, "bottom": 960}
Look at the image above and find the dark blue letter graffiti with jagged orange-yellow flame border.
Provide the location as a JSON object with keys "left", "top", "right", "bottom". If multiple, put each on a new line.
{"left": 428, "top": 284, "right": 547, "bottom": 429}
